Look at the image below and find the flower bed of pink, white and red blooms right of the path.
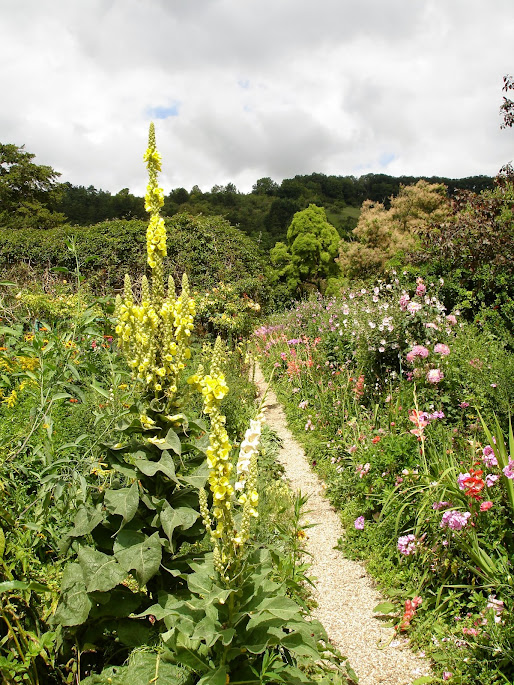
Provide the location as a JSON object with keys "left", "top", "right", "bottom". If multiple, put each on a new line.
{"left": 254, "top": 274, "right": 514, "bottom": 683}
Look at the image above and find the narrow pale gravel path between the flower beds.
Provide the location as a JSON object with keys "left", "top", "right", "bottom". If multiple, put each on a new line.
{"left": 255, "top": 365, "right": 430, "bottom": 685}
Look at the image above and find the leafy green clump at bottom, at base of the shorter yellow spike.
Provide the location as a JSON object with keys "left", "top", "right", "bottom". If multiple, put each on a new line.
{"left": 142, "top": 550, "right": 332, "bottom": 685}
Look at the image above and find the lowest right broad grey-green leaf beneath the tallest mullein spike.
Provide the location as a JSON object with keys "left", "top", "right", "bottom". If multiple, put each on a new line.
{"left": 114, "top": 530, "right": 162, "bottom": 586}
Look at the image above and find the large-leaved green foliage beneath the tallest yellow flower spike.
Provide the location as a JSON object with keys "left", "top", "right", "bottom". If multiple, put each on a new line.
{"left": 53, "top": 401, "right": 210, "bottom": 655}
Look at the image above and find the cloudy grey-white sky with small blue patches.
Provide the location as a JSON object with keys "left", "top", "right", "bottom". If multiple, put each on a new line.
{"left": 0, "top": 0, "right": 514, "bottom": 195}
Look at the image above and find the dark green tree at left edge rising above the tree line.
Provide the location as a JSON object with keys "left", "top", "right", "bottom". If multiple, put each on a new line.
{"left": 0, "top": 143, "right": 65, "bottom": 228}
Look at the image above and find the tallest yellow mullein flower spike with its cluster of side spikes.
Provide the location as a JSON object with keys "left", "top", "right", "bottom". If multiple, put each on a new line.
{"left": 115, "top": 123, "right": 195, "bottom": 399}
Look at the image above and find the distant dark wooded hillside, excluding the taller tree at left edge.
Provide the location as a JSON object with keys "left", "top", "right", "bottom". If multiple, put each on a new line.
{"left": 52, "top": 168, "right": 492, "bottom": 251}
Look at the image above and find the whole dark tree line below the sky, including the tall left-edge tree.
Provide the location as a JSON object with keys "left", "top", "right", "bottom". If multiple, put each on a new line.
{"left": 0, "top": 144, "right": 493, "bottom": 250}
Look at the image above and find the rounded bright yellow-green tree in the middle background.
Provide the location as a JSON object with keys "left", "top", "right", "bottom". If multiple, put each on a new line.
{"left": 270, "top": 204, "right": 339, "bottom": 290}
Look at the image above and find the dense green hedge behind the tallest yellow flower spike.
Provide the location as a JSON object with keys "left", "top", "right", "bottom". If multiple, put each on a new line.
{"left": 0, "top": 214, "right": 271, "bottom": 296}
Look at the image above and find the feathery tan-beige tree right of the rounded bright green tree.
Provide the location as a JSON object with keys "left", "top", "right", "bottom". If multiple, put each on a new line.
{"left": 337, "top": 180, "right": 450, "bottom": 277}
